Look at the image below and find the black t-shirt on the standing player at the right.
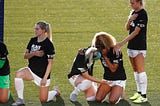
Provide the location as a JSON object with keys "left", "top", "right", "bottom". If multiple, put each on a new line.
{"left": 127, "top": 9, "right": 148, "bottom": 50}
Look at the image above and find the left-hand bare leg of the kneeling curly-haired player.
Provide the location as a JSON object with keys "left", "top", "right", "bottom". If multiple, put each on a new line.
{"left": 96, "top": 84, "right": 111, "bottom": 102}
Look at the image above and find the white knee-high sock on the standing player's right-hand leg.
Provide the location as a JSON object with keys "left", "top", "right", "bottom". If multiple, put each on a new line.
{"left": 139, "top": 72, "right": 147, "bottom": 95}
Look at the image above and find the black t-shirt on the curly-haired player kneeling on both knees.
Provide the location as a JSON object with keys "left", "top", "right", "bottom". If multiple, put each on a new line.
{"left": 100, "top": 49, "right": 126, "bottom": 81}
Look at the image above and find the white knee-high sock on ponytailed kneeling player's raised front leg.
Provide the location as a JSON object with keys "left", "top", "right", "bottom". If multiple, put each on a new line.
{"left": 14, "top": 78, "right": 24, "bottom": 99}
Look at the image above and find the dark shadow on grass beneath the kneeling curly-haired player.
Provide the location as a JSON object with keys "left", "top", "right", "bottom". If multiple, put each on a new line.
{"left": 88, "top": 100, "right": 131, "bottom": 106}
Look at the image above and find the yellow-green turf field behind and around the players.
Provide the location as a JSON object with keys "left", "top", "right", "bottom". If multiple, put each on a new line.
{"left": 0, "top": 0, "right": 160, "bottom": 106}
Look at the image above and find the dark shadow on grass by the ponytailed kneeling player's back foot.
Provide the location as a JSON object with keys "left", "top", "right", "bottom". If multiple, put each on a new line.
{"left": 41, "top": 96, "right": 65, "bottom": 106}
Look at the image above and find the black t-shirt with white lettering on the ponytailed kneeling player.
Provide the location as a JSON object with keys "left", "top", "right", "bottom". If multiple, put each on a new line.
{"left": 27, "top": 37, "right": 55, "bottom": 79}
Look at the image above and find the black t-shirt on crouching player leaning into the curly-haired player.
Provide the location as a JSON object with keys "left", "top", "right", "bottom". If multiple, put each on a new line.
{"left": 68, "top": 51, "right": 94, "bottom": 78}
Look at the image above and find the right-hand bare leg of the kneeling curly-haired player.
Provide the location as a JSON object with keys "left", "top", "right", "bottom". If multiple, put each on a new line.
{"left": 109, "top": 85, "right": 123, "bottom": 104}
